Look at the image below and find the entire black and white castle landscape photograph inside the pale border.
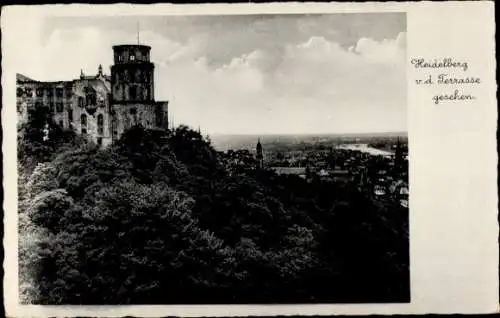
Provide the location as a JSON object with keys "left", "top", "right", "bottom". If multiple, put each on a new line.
{"left": 15, "top": 12, "right": 411, "bottom": 305}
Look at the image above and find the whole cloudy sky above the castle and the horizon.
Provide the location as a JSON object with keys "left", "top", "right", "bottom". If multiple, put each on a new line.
{"left": 17, "top": 13, "right": 407, "bottom": 134}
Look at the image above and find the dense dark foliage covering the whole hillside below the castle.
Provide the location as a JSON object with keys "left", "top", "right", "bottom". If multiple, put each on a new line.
{"left": 18, "top": 114, "right": 409, "bottom": 304}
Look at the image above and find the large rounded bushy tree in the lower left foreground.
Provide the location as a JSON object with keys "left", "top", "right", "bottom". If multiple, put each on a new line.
{"left": 39, "top": 182, "right": 232, "bottom": 304}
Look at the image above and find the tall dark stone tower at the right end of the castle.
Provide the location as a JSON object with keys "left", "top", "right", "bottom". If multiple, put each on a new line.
{"left": 111, "top": 44, "right": 168, "bottom": 140}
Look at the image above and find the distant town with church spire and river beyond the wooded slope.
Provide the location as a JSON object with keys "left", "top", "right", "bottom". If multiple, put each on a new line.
{"left": 221, "top": 137, "right": 409, "bottom": 208}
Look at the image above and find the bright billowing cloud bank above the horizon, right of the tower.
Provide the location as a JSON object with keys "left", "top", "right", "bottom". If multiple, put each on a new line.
{"left": 161, "top": 35, "right": 406, "bottom": 133}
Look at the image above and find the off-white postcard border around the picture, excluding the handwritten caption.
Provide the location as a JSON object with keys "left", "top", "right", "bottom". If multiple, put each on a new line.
{"left": 2, "top": 1, "right": 498, "bottom": 317}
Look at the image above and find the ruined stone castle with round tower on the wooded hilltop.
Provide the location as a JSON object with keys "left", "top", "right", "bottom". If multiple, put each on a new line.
{"left": 16, "top": 45, "right": 168, "bottom": 146}
